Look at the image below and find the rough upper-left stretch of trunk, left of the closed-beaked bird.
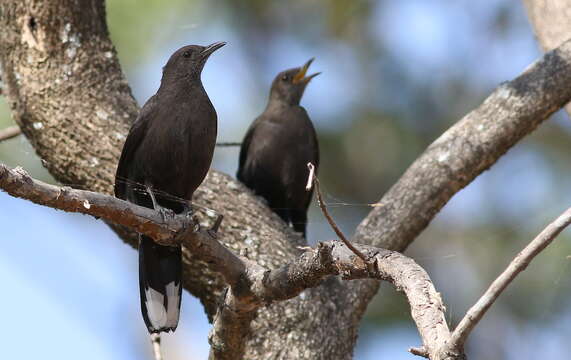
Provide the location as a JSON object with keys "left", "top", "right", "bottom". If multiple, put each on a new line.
{"left": 0, "top": 0, "right": 137, "bottom": 193}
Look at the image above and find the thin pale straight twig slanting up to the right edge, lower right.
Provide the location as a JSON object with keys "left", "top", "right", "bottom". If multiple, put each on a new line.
{"left": 449, "top": 208, "right": 571, "bottom": 349}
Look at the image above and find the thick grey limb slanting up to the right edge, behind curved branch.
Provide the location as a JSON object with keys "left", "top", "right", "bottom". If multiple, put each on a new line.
{"left": 354, "top": 41, "right": 571, "bottom": 251}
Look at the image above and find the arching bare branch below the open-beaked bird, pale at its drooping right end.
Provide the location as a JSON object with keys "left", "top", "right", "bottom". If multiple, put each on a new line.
{"left": 210, "top": 241, "right": 456, "bottom": 359}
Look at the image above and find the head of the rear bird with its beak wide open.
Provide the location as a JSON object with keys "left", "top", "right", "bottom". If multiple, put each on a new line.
{"left": 270, "top": 58, "right": 321, "bottom": 105}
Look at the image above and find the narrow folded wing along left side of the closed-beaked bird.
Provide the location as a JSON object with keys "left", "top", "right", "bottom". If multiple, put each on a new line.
{"left": 115, "top": 96, "right": 154, "bottom": 199}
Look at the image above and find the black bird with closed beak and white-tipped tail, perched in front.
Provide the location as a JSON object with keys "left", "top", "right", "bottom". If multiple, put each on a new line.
{"left": 115, "top": 42, "right": 226, "bottom": 333}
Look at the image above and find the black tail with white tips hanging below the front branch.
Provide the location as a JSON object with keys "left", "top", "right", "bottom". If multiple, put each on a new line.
{"left": 139, "top": 235, "right": 182, "bottom": 333}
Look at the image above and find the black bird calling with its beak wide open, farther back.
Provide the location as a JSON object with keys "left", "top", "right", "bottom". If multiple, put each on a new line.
{"left": 237, "top": 59, "right": 319, "bottom": 237}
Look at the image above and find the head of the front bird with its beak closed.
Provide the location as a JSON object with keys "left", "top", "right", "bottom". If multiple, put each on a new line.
{"left": 163, "top": 41, "right": 226, "bottom": 79}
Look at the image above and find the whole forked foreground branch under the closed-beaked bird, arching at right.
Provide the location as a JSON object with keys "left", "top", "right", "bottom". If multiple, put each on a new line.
{"left": 0, "top": 164, "right": 450, "bottom": 359}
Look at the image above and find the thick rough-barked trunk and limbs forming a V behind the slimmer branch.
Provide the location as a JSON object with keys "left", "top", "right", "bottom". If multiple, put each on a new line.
{"left": 0, "top": 0, "right": 571, "bottom": 359}
